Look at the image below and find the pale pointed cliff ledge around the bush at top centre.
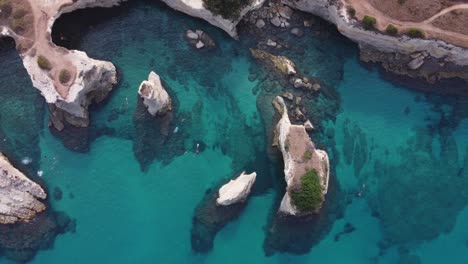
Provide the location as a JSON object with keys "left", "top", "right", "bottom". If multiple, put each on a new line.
{"left": 162, "top": 0, "right": 265, "bottom": 38}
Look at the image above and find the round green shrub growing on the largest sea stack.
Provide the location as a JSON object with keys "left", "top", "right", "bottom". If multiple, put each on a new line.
{"left": 291, "top": 170, "right": 323, "bottom": 212}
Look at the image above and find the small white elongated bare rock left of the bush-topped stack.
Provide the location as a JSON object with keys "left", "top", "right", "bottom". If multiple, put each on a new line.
{"left": 216, "top": 172, "right": 257, "bottom": 206}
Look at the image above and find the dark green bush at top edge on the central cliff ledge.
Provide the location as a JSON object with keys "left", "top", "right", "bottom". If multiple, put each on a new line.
{"left": 203, "top": 0, "right": 251, "bottom": 19}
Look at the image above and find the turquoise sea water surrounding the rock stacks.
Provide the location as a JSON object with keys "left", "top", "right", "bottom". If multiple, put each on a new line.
{"left": 0, "top": 3, "right": 468, "bottom": 263}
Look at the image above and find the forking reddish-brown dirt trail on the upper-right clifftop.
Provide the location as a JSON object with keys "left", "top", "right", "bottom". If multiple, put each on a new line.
{"left": 347, "top": 0, "right": 468, "bottom": 48}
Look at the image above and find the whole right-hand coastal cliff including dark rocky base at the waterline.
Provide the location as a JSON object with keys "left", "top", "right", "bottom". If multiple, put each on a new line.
{"left": 282, "top": 0, "right": 468, "bottom": 84}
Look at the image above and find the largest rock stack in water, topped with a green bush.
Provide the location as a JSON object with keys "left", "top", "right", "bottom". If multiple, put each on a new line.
{"left": 273, "top": 97, "right": 330, "bottom": 216}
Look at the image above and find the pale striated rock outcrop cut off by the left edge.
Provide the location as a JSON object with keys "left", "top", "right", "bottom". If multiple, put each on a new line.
{"left": 0, "top": 154, "right": 47, "bottom": 224}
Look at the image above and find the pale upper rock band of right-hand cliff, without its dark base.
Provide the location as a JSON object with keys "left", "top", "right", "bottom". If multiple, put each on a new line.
{"left": 282, "top": 0, "right": 468, "bottom": 66}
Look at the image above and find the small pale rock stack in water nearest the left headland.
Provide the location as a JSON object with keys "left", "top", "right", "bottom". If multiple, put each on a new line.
{"left": 138, "top": 71, "right": 172, "bottom": 116}
